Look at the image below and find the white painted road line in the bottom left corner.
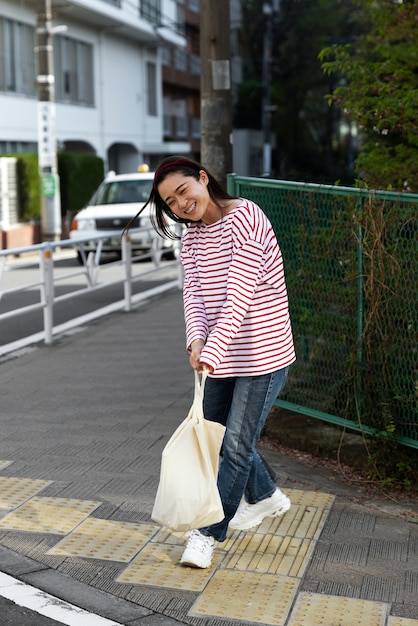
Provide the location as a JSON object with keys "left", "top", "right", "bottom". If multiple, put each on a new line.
{"left": 0, "top": 573, "right": 122, "bottom": 626}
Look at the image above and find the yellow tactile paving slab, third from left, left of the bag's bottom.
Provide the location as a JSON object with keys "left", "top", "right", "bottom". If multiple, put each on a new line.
{"left": 47, "top": 517, "right": 157, "bottom": 563}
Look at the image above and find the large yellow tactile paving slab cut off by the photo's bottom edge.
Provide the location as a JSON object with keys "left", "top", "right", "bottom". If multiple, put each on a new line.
{"left": 287, "top": 592, "right": 388, "bottom": 626}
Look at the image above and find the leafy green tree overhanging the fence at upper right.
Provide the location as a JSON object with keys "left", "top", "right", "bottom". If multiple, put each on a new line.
{"left": 320, "top": 0, "right": 418, "bottom": 192}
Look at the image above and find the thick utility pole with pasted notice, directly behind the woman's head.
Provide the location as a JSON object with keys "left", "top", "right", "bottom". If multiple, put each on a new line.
{"left": 200, "top": 0, "right": 232, "bottom": 184}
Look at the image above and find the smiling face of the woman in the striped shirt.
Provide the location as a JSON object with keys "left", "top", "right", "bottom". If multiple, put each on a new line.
{"left": 158, "top": 170, "right": 220, "bottom": 224}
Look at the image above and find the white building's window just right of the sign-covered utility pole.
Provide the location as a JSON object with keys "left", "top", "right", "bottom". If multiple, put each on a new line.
{"left": 54, "top": 37, "right": 94, "bottom": 106}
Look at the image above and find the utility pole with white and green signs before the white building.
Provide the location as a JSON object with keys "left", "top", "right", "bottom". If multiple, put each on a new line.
{"left": 36, "top": 0, "right": 67, "bottom": 241}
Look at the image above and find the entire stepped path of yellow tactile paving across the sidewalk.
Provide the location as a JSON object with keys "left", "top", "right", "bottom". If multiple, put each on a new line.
{"left": 0, "top": 480, "right": 408, "bottom": 626}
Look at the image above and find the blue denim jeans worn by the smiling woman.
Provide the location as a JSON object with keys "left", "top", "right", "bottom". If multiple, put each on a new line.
{"left": 199, "top": 367, "right": 289, "bottom": 541}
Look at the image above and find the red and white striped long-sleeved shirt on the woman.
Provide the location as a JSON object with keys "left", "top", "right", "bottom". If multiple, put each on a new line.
{"left": 182, "top": 199, "right": 296, "bottom": 378}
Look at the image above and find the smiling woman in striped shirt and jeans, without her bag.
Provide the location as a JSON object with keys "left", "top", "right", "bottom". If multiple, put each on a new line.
{"left": 125, "top": 156, "right": 295, "bottom": 568}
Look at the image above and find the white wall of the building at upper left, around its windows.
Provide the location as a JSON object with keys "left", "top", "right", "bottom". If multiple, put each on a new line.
{"left": 0, "top": 0, "right": 184, "bottom": 172}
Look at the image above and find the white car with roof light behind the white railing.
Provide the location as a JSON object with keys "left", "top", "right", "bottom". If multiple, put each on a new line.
{"left": 70, "top": 167, "right": 177, "bottom": 261}
